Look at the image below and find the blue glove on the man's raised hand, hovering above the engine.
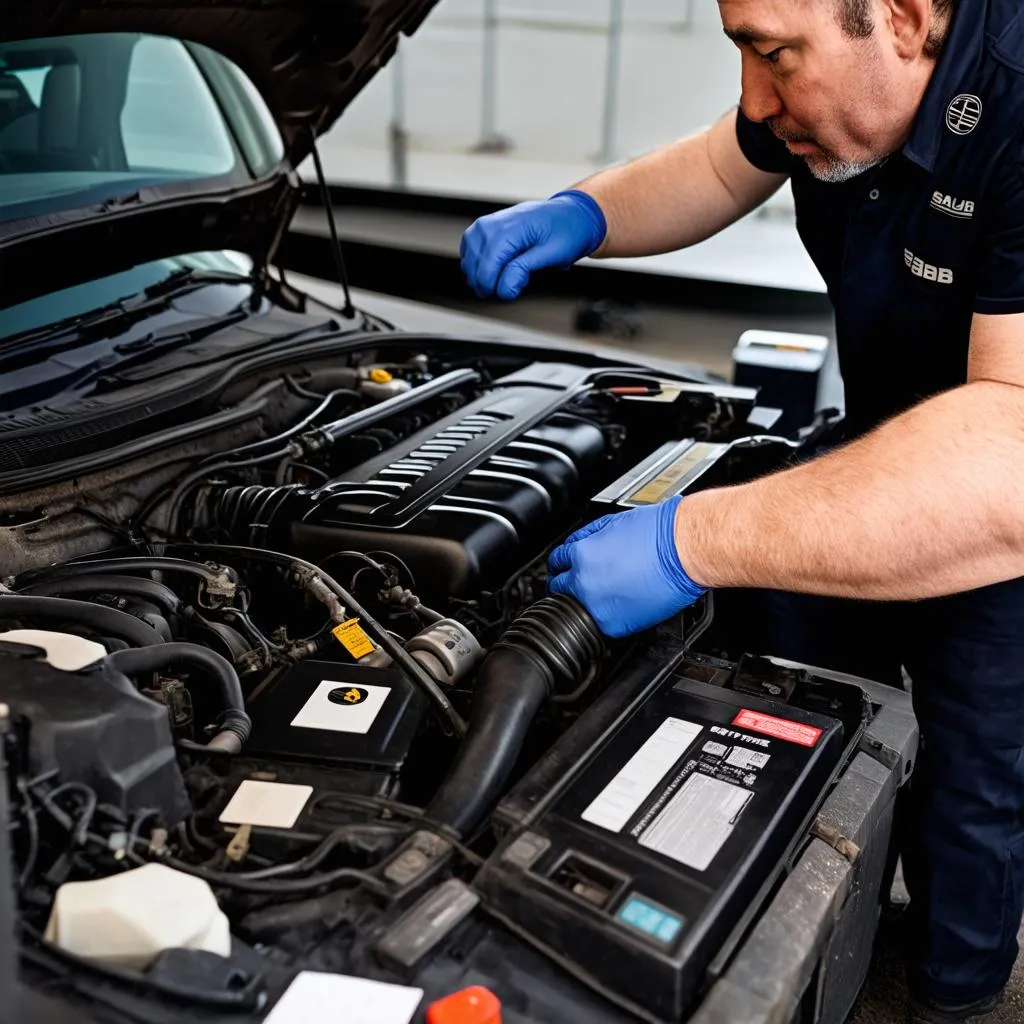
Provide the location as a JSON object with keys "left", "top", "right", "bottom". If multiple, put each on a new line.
{"left": 461, "top": 188, "right": 608, "bottom": 301}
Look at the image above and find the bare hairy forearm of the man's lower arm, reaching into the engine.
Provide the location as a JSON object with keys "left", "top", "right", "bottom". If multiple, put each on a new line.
{"left": 676, "top": 381, "right": 1024, "bottom": 600}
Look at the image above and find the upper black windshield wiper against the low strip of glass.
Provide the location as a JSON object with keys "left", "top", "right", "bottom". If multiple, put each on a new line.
{"left": 0, "top": 267, "right": 253, "bottom": 356}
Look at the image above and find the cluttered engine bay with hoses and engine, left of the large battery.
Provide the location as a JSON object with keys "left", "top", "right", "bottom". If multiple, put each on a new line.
{"left": 0, "top": 341, "right": 862, "bottom": 1020}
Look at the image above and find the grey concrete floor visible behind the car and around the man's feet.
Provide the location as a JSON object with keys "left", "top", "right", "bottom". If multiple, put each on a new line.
{"left": 425, "top": 290, "right": 1024, "bottom": 1024}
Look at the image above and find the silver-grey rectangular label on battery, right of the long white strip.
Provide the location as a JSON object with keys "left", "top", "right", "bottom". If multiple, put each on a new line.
{"left": 639, "top": 774, "right": 754, "bottom": 871}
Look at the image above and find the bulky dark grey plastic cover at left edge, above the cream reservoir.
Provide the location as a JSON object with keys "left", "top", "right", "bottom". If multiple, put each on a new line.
{"left": 0, "top": 644, "right": 191, "bottom": 825}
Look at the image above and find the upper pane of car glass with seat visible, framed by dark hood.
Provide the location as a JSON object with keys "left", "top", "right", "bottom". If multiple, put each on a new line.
{"left": 0, "top": 33, "right": 283, "bottom": 222}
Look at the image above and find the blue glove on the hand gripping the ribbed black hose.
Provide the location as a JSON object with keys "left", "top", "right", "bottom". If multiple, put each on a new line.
{"left": 548, "top": 496, "right": 707, "bottom": 637}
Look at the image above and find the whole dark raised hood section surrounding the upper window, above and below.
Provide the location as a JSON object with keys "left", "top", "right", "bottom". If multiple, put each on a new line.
{"left": 0, "top": 0, "right": 437, "bottom": 304}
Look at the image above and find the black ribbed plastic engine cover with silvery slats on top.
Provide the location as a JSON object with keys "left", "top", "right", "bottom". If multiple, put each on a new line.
{"left": 288, "top": 367, "right": 606, "bottom": 597}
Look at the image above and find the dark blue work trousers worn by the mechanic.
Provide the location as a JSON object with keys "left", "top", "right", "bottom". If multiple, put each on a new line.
{"left": 763, "top": 580, "right": 1024, "bottom": 1004}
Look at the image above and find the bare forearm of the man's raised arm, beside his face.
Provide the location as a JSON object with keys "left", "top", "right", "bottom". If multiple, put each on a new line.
{"left": 577, "top": 111, "right": 784, "bottom": 258}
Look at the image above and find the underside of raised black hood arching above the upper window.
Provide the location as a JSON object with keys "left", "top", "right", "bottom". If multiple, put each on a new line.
{"left": 0, "top": 0, "right": 437, "bottom": 167}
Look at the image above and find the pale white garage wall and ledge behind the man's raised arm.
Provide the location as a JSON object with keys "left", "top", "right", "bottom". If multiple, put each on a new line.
{"left": 315, "top": 0, "right": 824, "bottom": 292}
